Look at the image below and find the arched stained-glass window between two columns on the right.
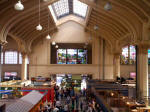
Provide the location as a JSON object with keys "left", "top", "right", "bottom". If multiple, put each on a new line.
{"left": 121, "top": 45, "right": 136, "bottom": 64}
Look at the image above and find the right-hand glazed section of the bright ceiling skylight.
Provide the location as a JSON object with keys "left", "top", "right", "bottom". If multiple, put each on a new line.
{"left": 73, "top": 0, "right": 88, "bottom": 17}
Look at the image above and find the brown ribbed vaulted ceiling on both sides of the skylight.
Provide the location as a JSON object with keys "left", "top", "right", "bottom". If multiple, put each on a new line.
{"left": 0, "top": 0, "right": 150, "bottom": 53}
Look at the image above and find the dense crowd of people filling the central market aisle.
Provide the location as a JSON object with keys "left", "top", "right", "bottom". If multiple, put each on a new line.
{"left": 41, "top": 86, "right": 103, "bottom": 112}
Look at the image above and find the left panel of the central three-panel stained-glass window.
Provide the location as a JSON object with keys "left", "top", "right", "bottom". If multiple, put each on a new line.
{"left": 57, "top": 49, "right": 66, "bottom": 64}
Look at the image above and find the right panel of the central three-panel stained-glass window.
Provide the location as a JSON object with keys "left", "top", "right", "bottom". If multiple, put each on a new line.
{"left": 78, "top": 49, "right": 87, "bottom": 64}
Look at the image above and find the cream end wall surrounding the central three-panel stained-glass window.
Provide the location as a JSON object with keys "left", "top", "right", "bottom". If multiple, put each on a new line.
{"left": 29, "top": 21, "right": 113, "bottom": 79}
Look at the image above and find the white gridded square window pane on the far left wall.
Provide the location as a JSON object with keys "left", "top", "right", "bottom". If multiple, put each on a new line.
{"left": 5, "top": 51, "right": 18, "bottom": 64}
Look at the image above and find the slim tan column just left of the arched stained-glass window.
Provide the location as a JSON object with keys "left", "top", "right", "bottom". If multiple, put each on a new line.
{"left": 114, "top": 53, "right": 120, "bottom": 79}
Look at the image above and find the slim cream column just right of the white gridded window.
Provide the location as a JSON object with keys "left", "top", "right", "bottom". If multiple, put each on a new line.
{"left": 21, "top": 53, "right": 28, "bottom": 81}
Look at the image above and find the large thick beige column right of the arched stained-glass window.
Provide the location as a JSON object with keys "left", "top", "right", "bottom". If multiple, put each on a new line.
{"left": 136, "top": 45, "right": 149, "bottom": 101}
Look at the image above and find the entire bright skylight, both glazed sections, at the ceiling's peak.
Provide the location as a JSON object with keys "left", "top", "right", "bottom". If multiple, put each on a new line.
{"left": 49, "top": 0, "right": 88, "bottom": 19}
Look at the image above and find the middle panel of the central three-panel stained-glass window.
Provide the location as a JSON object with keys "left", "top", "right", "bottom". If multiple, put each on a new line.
{"left": 67, "top": 49, "right": 77, "bottom": 64}
